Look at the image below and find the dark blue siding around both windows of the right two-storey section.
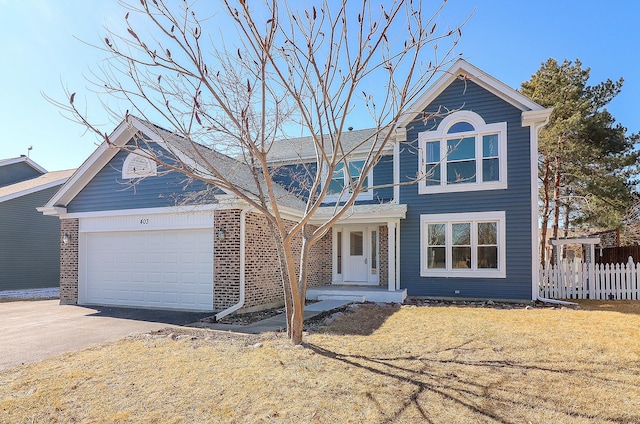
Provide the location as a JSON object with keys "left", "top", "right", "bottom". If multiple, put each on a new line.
{"left": 400, "top": 80, "right": 537, "bottom": 299}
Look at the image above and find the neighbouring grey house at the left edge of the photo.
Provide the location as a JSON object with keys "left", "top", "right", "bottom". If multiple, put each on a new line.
{"left": 0, "top": 156, "right": 73, "bottom": 291}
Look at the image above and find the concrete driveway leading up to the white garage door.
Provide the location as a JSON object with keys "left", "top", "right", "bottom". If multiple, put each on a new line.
{"left": 0, "top": 300, "right": 212, "bottom": 370}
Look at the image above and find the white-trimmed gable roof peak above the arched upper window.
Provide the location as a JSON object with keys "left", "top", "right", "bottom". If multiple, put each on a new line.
{"left": 398, "top": 59, "right": 551, "bottom": 127}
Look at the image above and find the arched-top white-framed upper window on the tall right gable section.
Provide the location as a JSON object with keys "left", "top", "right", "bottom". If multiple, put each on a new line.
{"left": 418, "top": 111, "right": 507, "bottom": 194}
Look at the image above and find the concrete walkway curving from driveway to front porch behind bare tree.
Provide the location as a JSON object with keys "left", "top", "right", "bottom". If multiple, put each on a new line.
{"left": 190, "top": 300, "right": 352, "bottom": 334}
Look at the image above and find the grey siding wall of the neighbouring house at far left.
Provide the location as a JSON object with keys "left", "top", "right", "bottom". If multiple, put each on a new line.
{"left": 0, "top": 186, "right": 60, "bottom": 291}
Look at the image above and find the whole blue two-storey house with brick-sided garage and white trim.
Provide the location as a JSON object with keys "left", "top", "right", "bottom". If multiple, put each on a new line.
{"left": 41, "top": 60, "right": 551, "bottom": 313}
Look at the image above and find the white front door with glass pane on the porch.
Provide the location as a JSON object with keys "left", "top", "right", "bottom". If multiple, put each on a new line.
{"left": 342, "top": 226, "right": 377, "bottom": 284}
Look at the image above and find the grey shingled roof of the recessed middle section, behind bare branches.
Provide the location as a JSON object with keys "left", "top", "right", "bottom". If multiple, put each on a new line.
{"left": 268, "top": 128, "right": 393, "bottom": 162}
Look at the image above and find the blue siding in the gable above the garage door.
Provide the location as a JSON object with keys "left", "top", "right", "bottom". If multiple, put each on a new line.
{"left": 67, "top": 144, "right": 222, "bottom": 213}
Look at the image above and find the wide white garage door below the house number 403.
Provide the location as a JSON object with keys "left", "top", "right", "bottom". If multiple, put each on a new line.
{"left": 78, "top": 228, "right": 213, "bottom": 311}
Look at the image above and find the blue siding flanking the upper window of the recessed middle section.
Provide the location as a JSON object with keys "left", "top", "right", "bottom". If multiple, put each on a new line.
{"left": 272, "top": 155, "right": 393, "bottom": 205}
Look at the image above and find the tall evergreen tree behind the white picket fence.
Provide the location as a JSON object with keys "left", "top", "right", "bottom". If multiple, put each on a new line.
{"left": 521, "top": 59, "right": 639, "bottom": 263}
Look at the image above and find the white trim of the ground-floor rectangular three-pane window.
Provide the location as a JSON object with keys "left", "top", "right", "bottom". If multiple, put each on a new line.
{"left": 420, "top": 211, "right": 507, "bottom": 278}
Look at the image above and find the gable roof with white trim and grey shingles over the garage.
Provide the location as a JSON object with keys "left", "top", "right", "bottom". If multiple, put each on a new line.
{"left": 41, "top": 116, "right": 304, "bottom": 215}
